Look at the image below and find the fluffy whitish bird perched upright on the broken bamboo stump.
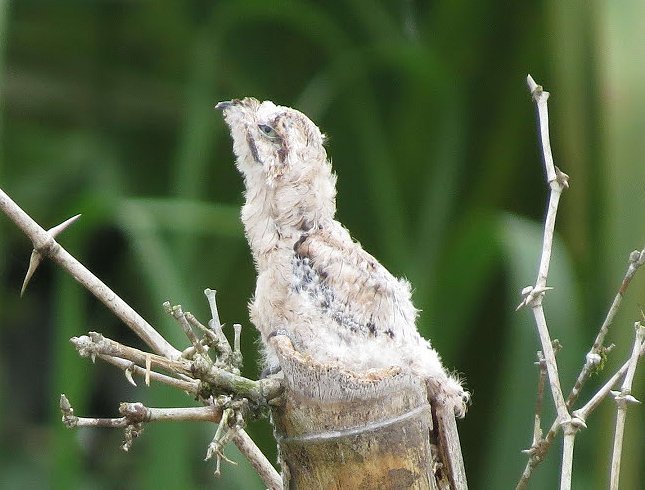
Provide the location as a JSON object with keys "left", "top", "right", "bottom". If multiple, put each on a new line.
{"left": 215, "top": 97, "right": 470, "bottom": 417}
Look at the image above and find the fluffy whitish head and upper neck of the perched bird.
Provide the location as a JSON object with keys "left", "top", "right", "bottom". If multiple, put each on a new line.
{"left": 215, "top": 97, "right": 336, "bottom": 234}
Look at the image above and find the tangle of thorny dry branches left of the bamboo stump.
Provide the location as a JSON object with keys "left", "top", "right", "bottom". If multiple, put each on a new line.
{"left": 0, "top": 189, "right": 282, "bottom": 489}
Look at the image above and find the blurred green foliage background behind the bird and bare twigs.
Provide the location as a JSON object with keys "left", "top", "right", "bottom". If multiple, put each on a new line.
{"left": 0, "top": 0, "right": 645, "bottom": 489}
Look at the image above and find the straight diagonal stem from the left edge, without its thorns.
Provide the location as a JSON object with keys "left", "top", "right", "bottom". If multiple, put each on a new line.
{"left": 0, "top": 189, "right": 180, "bottom": 359}
